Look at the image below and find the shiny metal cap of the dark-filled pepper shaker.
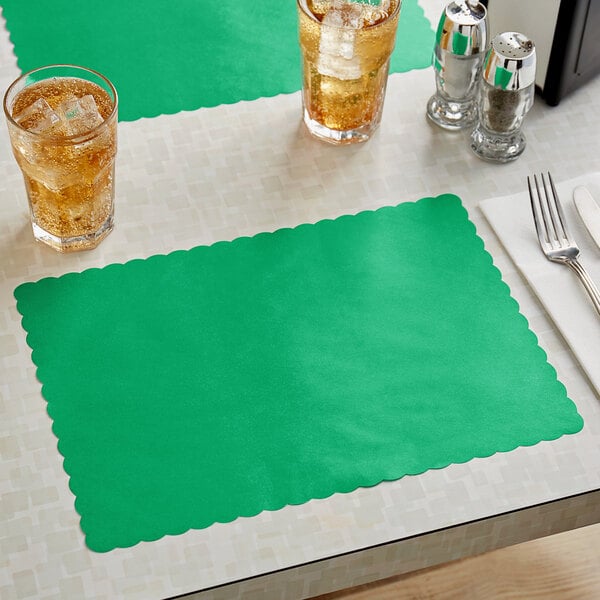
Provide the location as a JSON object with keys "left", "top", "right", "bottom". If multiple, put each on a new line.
{"left": 483, "top": 31, "right": 536, "bottom": 90}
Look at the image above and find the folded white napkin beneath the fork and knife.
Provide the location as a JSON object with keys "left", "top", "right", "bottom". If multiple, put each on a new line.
{"left": 480, "top": 172, "right": 600, "bottom": 394}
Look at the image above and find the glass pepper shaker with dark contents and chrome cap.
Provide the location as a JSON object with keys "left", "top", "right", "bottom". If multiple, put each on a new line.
{"left": 471, "top": 31, "right": 536, "bottom": 162}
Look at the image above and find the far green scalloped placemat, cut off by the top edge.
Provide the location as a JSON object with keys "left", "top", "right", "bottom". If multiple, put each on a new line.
{"left": 0, "top": 0, "right": 434, "bottom": 121}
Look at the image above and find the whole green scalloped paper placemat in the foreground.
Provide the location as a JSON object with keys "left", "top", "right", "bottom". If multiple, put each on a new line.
{"left": 15, "top": 195, "right": 583, "bottom": 552}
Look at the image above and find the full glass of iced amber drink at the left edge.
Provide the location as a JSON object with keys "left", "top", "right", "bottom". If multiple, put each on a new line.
{"left": 4, "top": 65, "right": 117, "bottom": 252}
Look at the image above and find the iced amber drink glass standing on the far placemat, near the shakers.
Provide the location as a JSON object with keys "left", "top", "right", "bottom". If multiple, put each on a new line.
{"left": 297, "top": 0, "right": 401, "bottom": 144}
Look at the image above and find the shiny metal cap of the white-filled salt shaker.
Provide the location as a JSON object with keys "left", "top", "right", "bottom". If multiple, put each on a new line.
{"left": 436, "top": 0, "right": 487, "bottom": 56}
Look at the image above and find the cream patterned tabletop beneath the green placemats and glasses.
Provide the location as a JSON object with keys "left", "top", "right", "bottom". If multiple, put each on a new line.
{"left": 0, "top": 0, "right": 600, "bottom": 599}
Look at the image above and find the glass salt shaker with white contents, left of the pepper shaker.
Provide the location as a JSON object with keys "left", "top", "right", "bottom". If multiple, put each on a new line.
{"left": 427, "top": 0, "right": 487, "bottom": 130}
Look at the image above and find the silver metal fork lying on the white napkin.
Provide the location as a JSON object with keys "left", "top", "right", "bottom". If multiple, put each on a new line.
{"left": 527, "top": 173, "right": 600, "bottom": 315}
